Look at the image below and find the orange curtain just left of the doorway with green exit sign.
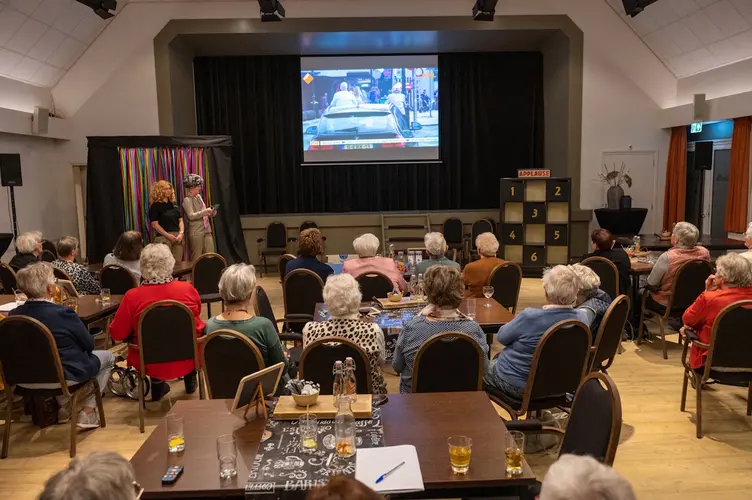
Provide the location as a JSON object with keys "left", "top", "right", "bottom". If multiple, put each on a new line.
{"left": 663, "top": 127, "right": 687, "bottom": 231}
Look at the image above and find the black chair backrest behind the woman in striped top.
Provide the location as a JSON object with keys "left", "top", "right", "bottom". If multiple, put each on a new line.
{"left": 412, "top": 332, "right": 486, "bottom": 393}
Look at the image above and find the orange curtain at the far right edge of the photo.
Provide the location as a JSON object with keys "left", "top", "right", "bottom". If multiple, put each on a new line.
{"left": 724, "top": 116, "right": 752, "bottom": 233}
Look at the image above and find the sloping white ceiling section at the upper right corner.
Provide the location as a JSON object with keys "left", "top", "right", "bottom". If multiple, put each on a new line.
{"left": 606, "top": 0, "right": 752, "bottom": 78}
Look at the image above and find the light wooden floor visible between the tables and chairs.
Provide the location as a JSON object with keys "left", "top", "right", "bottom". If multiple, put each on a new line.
{"left": 0, "top": 278, "right": 752, "bottom": 500}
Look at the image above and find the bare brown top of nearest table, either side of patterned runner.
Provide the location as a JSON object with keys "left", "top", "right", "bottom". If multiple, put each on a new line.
{"left": 131, "top": 392, "right": 535, "bottom": 499}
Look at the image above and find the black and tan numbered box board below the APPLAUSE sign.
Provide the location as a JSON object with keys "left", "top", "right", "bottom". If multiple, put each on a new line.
{"left": 499, "top": 178, "right": 572, "bottom": 277}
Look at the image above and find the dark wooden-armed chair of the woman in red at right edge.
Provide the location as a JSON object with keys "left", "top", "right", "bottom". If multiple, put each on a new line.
{"left": 680, "top": 300, "right": 752, "bottom": 439}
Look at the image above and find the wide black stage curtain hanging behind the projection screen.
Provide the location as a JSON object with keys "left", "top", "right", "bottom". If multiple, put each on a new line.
{"left": 194, "top": 52, "right": 543, "bottom": 214}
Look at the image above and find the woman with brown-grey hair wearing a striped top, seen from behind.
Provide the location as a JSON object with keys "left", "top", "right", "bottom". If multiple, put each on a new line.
{"left": 392, "top": 266, "right": 489, "bottom": 394}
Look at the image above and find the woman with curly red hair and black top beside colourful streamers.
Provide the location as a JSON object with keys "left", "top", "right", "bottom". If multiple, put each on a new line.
{"left": 149, "top": 181, "right": 184, "bottom": 261}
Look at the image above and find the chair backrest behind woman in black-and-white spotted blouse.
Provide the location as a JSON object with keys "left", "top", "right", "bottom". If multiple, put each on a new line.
{"left": 298, "top": 337, "right": 373, "bottom": 395}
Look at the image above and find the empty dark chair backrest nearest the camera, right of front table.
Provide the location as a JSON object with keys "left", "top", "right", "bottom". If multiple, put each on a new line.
{"left": 559, "top": 373, "right": 622, "bottom": 466}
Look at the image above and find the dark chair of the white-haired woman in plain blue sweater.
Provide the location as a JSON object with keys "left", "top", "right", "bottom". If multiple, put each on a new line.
{"left": 486, "top": 320, "right": 591, "bottom": 420}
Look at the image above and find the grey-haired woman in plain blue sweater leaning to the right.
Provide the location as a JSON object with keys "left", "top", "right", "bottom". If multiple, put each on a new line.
{"left": 486, "top": 266, "right": 582, "bottom": 399}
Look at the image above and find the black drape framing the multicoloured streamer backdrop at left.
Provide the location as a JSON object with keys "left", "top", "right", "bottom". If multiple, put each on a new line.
{"left": 86, "top": 136, "right": 248, "bottom": 263}
